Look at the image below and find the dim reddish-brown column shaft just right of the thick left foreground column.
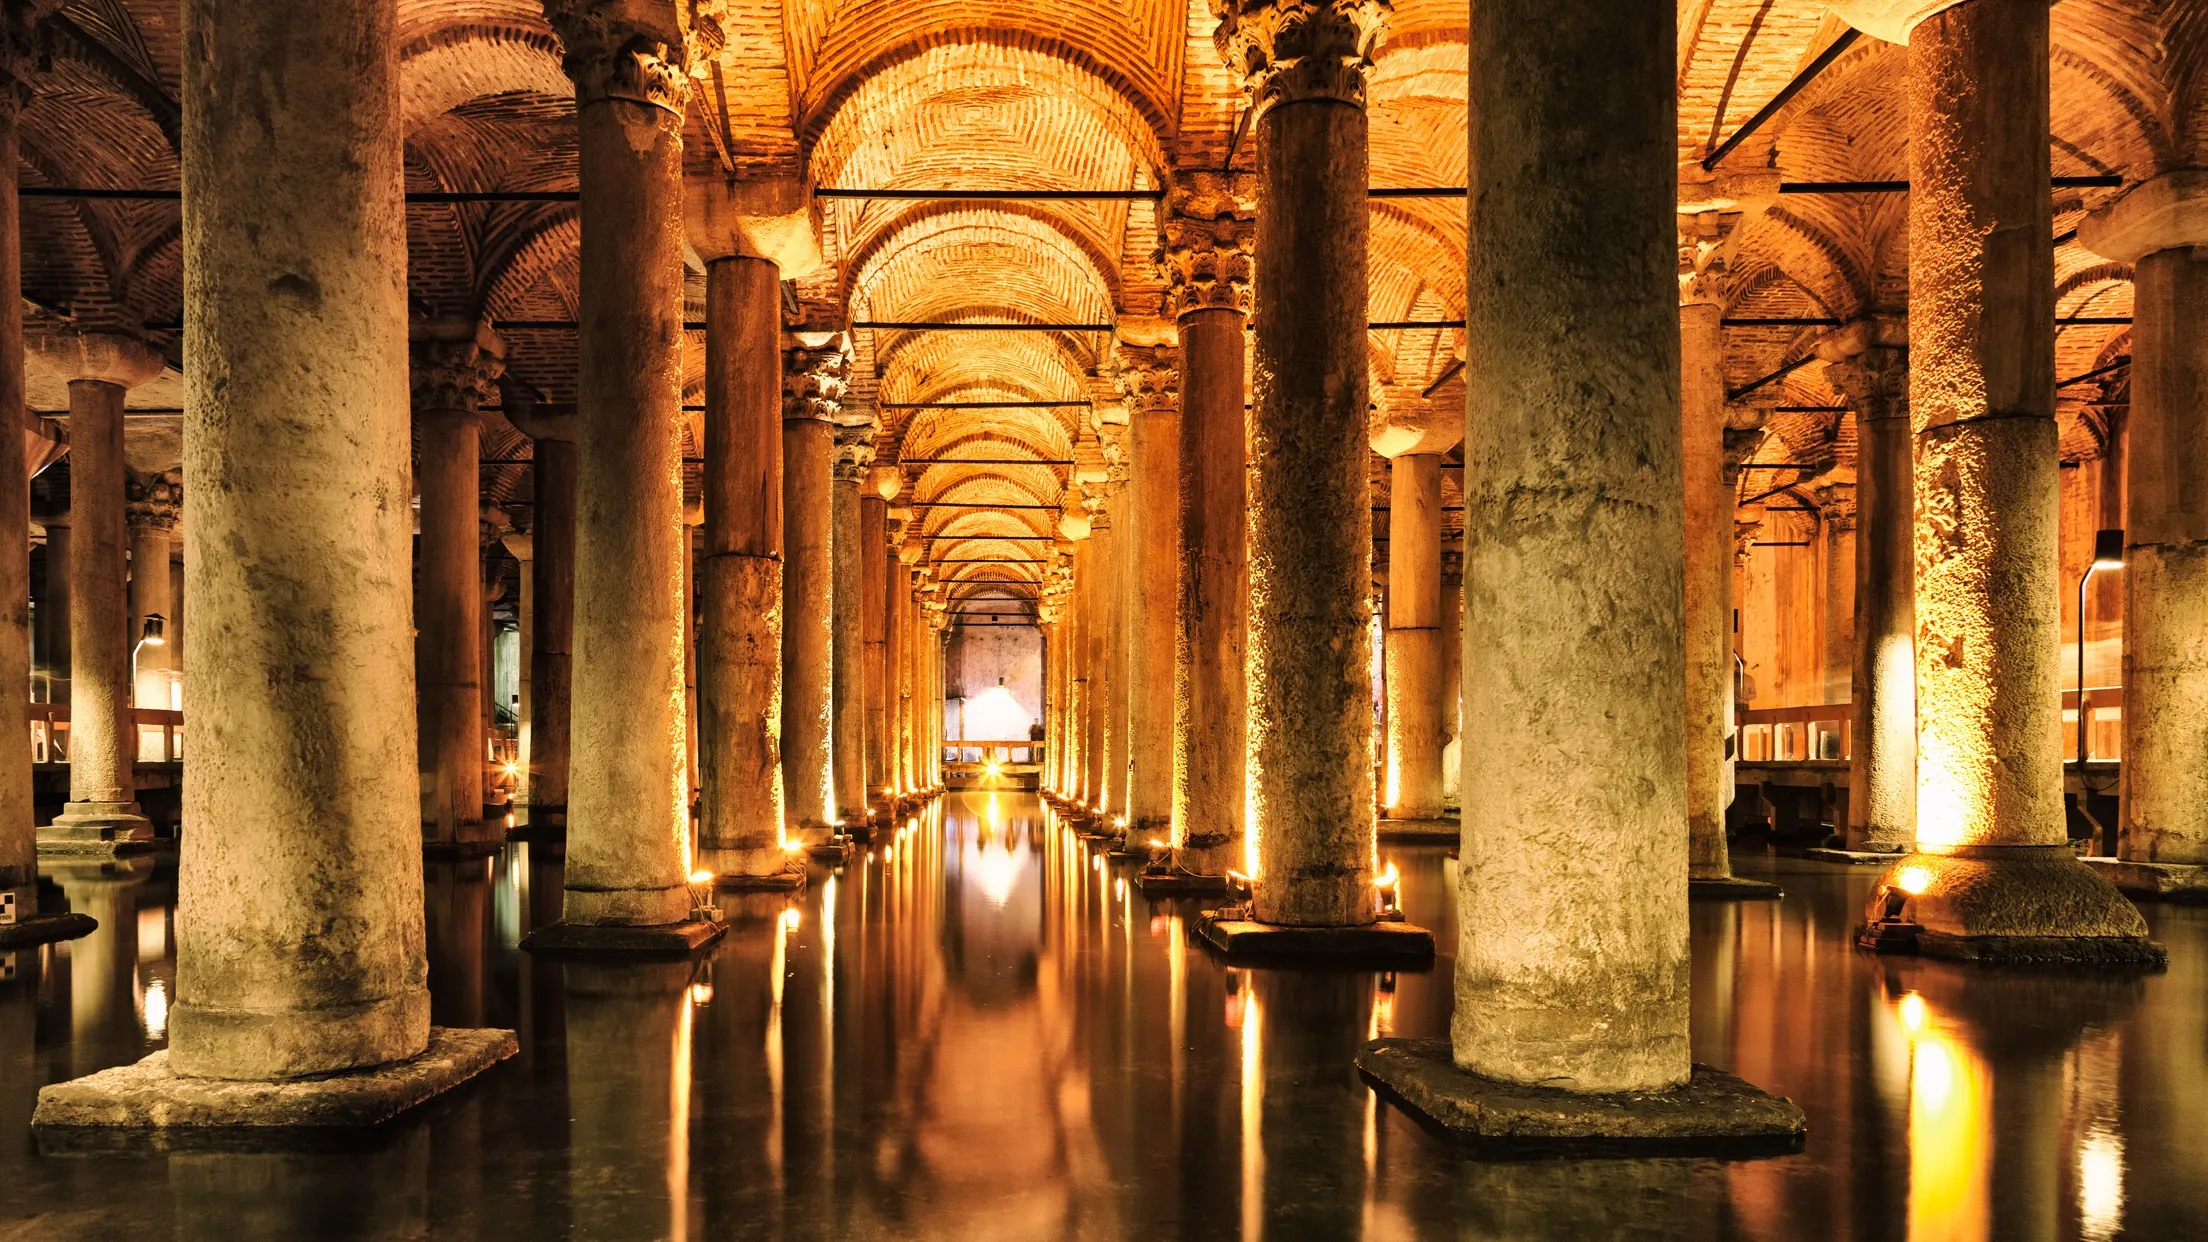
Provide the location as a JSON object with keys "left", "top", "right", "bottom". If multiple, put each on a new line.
{"left": 415, "top": 409, "right": 484, "bottom": 844}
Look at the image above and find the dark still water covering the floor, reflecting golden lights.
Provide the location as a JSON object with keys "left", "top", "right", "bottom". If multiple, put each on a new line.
{"left": 0, "top": 793, "right": 2208, "bottom": 1242}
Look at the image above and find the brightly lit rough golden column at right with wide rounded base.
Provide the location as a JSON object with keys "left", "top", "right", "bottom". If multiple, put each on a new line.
{"left": 1841, "top": 0, "right": 2162, "bottom": 964}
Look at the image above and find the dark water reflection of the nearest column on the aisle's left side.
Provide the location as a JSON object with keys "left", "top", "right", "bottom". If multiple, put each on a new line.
{"left": 565, "top": 961, "right": 691, "bottom": 1238}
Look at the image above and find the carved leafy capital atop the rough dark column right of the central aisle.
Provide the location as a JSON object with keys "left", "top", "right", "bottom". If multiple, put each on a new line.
{"left": 1212, "top": 0, "right": 1393, "bottom": 124}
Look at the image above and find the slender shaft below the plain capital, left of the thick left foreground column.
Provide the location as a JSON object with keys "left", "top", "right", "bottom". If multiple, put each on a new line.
{"left": 55, "top": 380, "right": 150, "bottom": 822}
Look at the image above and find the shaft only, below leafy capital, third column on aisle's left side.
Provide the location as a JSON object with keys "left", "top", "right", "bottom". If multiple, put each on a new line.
{"left": 782, "top": 418, "right": 837, "bottom": 830}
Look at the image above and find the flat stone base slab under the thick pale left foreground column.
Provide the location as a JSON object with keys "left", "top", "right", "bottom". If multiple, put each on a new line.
{"left": 31, "top": 1025, "right": 519, "bottom": 1151}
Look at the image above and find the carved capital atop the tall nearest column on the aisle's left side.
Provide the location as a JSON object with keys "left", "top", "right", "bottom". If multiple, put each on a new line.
{"left": 543, "top": 0, "right": 729, "bottom": 115}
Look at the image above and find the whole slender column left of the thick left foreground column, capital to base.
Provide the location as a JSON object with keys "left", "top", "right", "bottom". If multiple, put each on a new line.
{"left": 33, "top": 334, "right": 163, "bottom": 851}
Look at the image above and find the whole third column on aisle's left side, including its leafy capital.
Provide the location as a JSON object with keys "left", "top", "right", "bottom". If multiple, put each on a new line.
{"left": 782, "top": 331, "right": 850, "bottom": 846}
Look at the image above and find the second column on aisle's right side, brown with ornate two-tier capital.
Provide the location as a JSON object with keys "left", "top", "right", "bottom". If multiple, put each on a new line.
{"left": 1161, "top": 172, "right": 1256, "bottom": 877}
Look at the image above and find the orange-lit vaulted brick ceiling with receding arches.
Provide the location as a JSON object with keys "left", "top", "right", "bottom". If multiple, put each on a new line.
{"left": 20, "top": 0, "right": 2208, "bottom": 596}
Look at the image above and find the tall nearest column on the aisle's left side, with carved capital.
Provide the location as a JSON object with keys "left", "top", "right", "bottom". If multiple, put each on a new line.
{"left": 537, "top": 0, "right": 718, "bottom": 928}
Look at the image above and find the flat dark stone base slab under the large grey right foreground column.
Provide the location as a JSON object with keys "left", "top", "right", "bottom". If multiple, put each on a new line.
{"left": 1358, "top": 1039, "right": 1808, "bottom": 1160}
